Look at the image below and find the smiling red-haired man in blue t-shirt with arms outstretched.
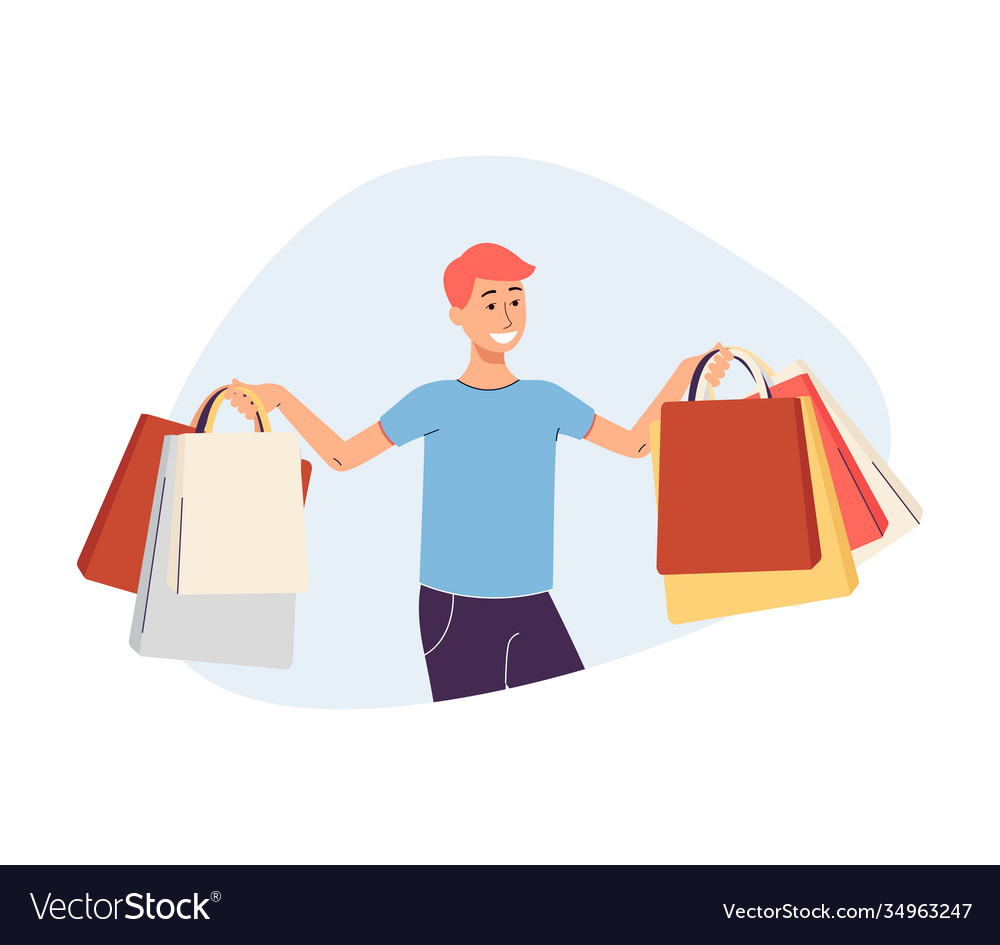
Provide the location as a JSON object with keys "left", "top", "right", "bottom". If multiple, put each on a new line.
{"left": 227, "top": 243, "right": 732, "bottom": 701}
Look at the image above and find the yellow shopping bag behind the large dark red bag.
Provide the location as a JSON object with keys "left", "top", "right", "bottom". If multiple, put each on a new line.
{"left": 649, "top": 397, "right": 858, "bottom": 623}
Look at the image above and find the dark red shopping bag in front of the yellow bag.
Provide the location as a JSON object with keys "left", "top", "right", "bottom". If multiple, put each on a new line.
{"left": 654, "top": 352, "right": 820, "bottom": 574}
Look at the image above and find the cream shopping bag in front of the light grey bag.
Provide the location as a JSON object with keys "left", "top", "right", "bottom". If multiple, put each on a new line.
{"left": 166, "top": 388, "right": 309, "bottom": 594}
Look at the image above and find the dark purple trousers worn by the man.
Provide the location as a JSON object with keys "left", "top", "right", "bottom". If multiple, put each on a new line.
{"left": 420, "top": 584, "right": 583, "bottom": 702}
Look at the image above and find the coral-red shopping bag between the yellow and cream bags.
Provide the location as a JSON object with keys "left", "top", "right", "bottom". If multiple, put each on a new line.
{"left": 750, "top": 374, "right": 889, "bottom": 551}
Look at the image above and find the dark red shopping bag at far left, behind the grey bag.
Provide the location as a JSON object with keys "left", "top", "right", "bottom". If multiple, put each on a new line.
{"left": 77, "top": 387, "right": 312, "bottom": 594}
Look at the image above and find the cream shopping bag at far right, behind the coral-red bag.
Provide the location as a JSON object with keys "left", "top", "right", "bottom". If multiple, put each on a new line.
{"left": 772, "top": 361, "right": 923, "bottom": 564}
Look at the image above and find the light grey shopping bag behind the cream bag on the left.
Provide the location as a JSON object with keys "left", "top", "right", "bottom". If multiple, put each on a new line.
{"left": 129, "top": 436, "right": 295, "bottom": 669}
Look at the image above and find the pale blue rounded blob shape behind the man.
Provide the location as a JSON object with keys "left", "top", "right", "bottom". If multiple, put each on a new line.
{"left": 171, "top": 157, "right": 889, "bottom": 708}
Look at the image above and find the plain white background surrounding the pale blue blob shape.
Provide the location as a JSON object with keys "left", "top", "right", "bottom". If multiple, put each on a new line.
{"left": 0, "top": 2, "right": 1000, "bottom": 863}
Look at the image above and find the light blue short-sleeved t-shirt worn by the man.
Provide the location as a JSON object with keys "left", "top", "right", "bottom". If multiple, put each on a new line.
{"left": 379, "top": 381, "right": 594, "bottom": 597}
